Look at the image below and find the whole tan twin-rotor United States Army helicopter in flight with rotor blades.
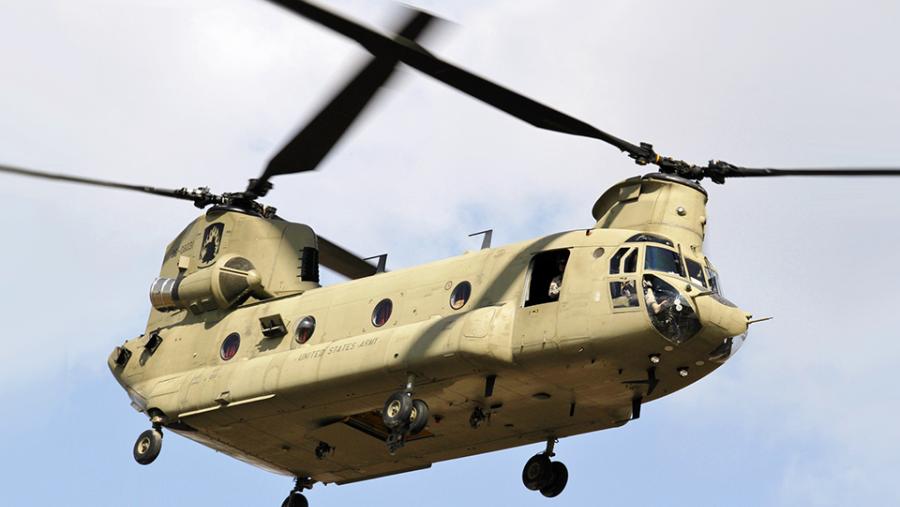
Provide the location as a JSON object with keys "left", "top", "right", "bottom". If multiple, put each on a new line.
{"left": 5, "top": 0, "right": 900, "bottom": 506}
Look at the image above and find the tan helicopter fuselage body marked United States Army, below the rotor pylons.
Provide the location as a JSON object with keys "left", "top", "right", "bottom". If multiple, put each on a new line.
{"left": 109, "top": 175, "right": 746, "bottom": 483}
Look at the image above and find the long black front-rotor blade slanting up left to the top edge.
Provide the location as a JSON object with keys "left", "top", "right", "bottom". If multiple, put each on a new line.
{"left": 268, "top": 0, "right": 655, "bottom": 163}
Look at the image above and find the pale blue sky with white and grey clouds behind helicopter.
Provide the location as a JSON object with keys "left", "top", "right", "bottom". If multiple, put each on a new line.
{"left": 0, "top": 0, "right": 900, "bottom": 506}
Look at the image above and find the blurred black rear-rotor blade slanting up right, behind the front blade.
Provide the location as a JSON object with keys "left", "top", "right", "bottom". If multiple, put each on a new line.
{"left": 247, "top": 11, "right": 435, "bottom": 196}
